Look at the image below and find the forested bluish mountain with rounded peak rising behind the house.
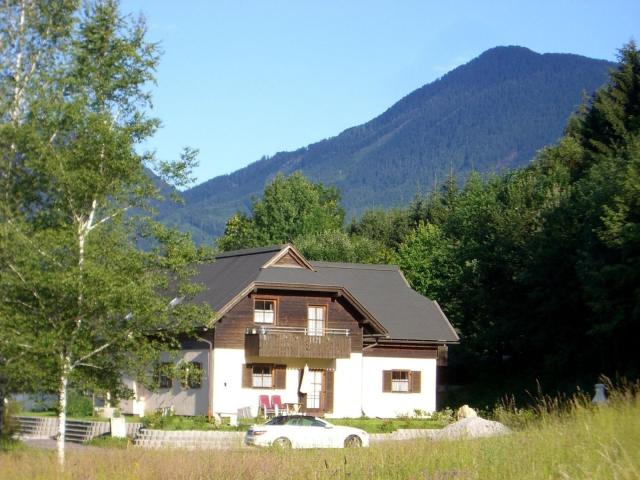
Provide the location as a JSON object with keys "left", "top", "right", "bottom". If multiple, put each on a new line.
{"left": 161, "top": 46, "right": 613, "bottom": 241}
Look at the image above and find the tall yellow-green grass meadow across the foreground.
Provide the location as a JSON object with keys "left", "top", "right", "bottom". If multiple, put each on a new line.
{"left": 0, "top": 388, "right": 640, "bottom": 480}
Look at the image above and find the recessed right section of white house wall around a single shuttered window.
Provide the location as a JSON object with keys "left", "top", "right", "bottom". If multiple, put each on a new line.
{"left": 362, "top": 356, "right": 436, "bottom": 418}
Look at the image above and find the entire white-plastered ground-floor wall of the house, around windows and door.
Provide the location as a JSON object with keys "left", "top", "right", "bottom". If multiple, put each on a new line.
{"left": 120, "top": 348, "right": 436, "bottom": 418}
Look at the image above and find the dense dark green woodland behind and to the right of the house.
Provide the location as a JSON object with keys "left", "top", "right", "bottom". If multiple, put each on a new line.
{"left": 219, "top": 43, "right": 640, "bottom": 404}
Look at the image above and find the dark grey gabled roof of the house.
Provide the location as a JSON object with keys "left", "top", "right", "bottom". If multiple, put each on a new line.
{"left": 195, "top": 245, "right": 458, "bottom": 343}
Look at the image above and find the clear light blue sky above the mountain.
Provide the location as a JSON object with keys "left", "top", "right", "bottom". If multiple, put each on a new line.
{"left": 122, "top": 0, "right": 640, "bottom": 182}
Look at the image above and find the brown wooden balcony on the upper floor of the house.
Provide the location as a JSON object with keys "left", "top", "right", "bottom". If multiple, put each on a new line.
{"left": 245, "top": 326, "right": 351, "bottom": 358}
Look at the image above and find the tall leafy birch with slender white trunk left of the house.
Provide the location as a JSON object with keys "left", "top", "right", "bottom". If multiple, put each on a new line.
{"left": 0, "top": 0, "right": 210, "bottom": 465}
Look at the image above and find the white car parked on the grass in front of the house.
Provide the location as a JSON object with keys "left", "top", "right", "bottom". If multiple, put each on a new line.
{"left": 244, "top": 415, "right": 369, "bottom": 448}
